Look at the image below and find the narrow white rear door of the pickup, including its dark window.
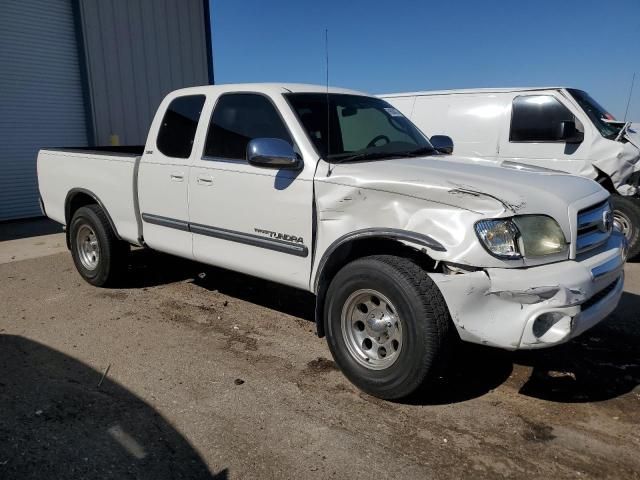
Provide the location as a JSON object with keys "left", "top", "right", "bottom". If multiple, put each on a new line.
{"left": 138, "top": 95, "right": 205, "bottom": 258}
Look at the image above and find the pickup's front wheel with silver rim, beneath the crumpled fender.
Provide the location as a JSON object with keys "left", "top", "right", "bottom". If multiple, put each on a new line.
{"left": 325, "top": 255, "right": 451, "bottom": 400}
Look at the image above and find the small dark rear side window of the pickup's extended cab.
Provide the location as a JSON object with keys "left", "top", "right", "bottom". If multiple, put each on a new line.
{"left": 156, "top": 95, "right": 205, "bottom": 158}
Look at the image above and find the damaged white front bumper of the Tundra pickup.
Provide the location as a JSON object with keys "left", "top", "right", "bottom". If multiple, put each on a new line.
{"left": 430, "top": 232, "right": 626, "bottom": 350}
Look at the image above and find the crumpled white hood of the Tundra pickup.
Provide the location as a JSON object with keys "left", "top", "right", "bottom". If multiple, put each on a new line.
{"left": 319, "top": 155, "right": 604, "bottom": 218}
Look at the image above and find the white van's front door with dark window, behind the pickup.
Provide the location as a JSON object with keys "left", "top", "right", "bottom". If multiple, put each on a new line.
{"left": 499, "top": 92, "right": 591, "bottom": 175}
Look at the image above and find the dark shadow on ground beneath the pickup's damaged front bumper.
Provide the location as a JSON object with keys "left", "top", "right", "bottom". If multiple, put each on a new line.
{"left": 390, "top": 292, "right": 640, "bottom": 405}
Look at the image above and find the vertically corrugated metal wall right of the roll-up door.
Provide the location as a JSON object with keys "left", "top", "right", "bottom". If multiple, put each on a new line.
{"left": 79, "top": 0, "right": 210, "bottom": 145}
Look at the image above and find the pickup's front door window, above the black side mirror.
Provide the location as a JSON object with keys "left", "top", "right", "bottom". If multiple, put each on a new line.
{"left": 204, "top": 93, "right": 293, "bottom": 160}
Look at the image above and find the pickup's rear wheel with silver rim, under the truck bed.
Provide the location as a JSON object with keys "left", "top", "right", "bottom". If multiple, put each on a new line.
{"left": 69, "top": 205, "right": 129, "bottom": 287}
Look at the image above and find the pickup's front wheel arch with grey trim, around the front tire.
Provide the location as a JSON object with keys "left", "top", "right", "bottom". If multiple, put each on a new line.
{"left": 313, "top": 228, "right": 446, "bottom": 337}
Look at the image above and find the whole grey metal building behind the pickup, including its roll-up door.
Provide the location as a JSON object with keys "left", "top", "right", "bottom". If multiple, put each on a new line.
{"left": 0, "top": 0, "right": 213, "bottom": 221}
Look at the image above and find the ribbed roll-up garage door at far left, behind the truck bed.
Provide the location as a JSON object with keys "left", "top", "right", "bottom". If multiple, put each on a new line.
{"left": 0, "top": 0, "right": 87, "bottom": 221}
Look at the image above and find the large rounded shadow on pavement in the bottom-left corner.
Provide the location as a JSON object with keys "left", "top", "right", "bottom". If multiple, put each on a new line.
{"left": 0, "top": 335, "right": 228, "bottom": 480}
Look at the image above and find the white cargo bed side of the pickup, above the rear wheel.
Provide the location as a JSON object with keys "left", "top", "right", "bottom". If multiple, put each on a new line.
{"left": 37, "top": 145, "right": 144, "bottom": 244}
